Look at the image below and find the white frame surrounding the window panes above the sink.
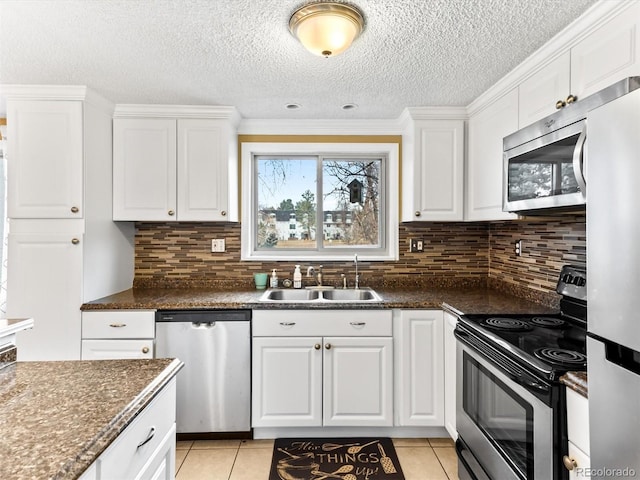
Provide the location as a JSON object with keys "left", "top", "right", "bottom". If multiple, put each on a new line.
{"left": 240, "top": 142, "right": 400, "bottom": 261}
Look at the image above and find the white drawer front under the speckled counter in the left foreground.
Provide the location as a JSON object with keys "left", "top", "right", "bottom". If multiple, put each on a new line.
{"left": 98, "top": 379, "right": 176, "bottom": 480}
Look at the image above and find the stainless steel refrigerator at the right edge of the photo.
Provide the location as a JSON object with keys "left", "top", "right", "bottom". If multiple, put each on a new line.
{"left": 587, "top": 85, "right": 640, "bottom": 479}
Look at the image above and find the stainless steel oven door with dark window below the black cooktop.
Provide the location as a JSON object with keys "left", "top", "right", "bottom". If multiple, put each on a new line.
{"left": 456, "top": 340, "right": 555, "bottom": 480}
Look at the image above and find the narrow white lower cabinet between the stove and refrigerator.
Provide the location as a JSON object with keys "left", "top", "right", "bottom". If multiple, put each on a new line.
{"left": 563, "top": 388, "right": 591, "bottom": 480}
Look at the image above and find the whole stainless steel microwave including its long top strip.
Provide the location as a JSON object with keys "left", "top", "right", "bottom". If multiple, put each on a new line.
{"left": 502, "top": 77, "right": 640, "bottom": 214}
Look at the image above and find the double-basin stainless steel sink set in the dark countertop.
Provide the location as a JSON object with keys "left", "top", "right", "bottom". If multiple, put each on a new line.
{"left": 260, "top": 288, "right": 382, "bottom": 303}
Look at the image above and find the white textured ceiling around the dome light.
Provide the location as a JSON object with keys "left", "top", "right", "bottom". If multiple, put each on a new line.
{"left": 0, "top": 0, "right": 595, "bottom": 119}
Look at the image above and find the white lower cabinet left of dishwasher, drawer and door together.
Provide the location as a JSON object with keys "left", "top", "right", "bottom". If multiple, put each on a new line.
{"left": 82, "top": 310, "right": 155, "bottom": 360}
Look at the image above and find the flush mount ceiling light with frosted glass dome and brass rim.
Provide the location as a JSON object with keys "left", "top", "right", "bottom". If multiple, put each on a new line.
{"left": 289, "top": 2, "right": 364, "bottom": 57}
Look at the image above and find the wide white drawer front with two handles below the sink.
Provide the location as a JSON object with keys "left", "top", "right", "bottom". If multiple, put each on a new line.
{"left": 252, "top": 310, "right": 393, "bottom": 337}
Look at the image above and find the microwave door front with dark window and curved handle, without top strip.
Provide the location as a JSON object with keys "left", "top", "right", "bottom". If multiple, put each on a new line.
{"left": 503, "top": 120, "right": 586, "bottom": 212}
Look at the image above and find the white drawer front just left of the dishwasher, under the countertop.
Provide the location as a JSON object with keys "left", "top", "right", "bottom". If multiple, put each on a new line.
{"left": 82, "top": 310, "right": 155, "bottom": 339}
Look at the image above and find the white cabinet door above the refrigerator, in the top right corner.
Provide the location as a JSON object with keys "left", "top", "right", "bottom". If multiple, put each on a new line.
{"left": 571, "top": 2, "right": 640, "bottom": 100}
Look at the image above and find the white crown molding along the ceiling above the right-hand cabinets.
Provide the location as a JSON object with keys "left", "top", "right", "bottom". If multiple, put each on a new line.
{"left": 467, "top": 0, "right": 638, "bottom": 116}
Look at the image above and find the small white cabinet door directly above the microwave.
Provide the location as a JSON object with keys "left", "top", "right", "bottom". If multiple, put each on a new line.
{"left": 518, "top": 52, "right": 571, "bottom": 128}
